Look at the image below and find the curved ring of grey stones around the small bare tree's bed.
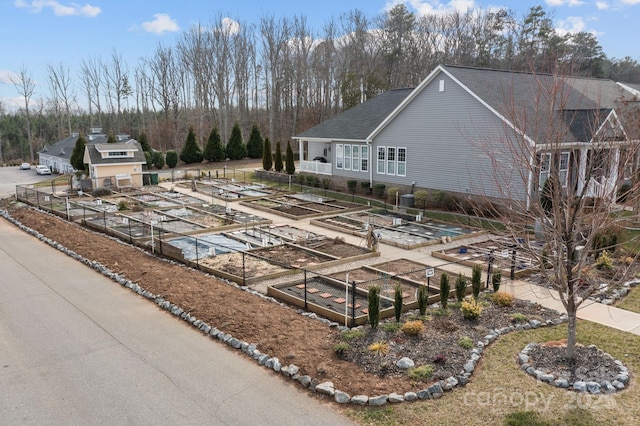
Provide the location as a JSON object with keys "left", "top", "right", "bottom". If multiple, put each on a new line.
{"left": 518, "top": 343, "right": 630, "bottom": 395}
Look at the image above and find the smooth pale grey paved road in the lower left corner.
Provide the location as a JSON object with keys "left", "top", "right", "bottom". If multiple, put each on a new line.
{"left": 0, "top": 219, "right": 350, "bottom": 425}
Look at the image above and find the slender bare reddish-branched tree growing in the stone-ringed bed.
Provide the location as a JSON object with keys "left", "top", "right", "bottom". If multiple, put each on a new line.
{"left": 476, "top": 68, "right": 639, "bottom": 360}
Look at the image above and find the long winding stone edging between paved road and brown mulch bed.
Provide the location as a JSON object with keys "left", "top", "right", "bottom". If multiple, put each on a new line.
{"left": 0, "top": 210, "right": 568, "bottom": 406}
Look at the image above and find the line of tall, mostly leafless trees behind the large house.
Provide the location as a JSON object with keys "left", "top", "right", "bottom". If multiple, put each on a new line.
{"left": 0, "top": 4, "right": 640, "bottom": 162}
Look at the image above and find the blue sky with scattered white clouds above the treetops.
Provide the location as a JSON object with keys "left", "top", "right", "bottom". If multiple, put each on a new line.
{"left": 0, "top": 0, "right": 640, "bottom": 109}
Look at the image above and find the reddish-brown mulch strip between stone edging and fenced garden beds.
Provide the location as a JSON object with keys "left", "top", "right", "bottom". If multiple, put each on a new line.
{"left": 2, "top": 206, "right": 616, "bottom": 402}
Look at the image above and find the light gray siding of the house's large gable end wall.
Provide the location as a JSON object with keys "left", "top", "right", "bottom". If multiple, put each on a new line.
{"left": 372, "top": 73, "right": 526, "bottom": 200}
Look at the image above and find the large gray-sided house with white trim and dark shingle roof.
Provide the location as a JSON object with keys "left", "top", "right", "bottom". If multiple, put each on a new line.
{"left": 293, "top": 65, "right": 638, "bottom": 210}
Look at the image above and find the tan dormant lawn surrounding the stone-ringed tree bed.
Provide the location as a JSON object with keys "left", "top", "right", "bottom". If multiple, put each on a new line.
{"left": 345, "top": 321, "right": 640, "bottom": 425}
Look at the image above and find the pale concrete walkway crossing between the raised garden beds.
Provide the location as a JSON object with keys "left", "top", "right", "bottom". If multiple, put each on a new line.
{"left": 161, "top": 183, "right": 640, "bottom": 335}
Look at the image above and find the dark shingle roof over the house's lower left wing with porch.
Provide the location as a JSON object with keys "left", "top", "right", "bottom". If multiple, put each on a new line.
{"left": 295, "top": 89, "right": 413, "bottom": 140}
